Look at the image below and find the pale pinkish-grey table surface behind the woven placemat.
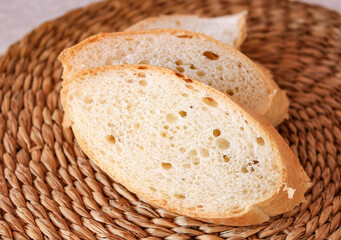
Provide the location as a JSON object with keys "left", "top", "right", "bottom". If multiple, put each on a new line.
{"left": 0, "top": 0, "right": 341, "bottom": 55}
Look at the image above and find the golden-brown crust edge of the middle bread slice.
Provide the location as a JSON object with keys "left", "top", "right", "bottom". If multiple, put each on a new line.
{"left": 58, "top": 29, "right": 289, "bottom": 126}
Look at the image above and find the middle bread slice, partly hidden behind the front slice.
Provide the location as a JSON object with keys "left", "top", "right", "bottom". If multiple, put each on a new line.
{"left": 59, "top": 29, "right": 289, "bottom": 126}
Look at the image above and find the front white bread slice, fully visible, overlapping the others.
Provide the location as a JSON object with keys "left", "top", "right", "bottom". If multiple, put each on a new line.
{"left": 61, "top": 65, "right": 309, "bottom": 225}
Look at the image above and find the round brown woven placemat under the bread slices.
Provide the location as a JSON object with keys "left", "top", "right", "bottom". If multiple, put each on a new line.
{"left": 0, "top": 0, "right": 341, "bottom": 240}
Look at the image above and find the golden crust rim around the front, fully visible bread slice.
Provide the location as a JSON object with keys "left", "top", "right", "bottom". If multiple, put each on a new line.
{"left": 61, "top": 65, "right": 310, "bottom": 226}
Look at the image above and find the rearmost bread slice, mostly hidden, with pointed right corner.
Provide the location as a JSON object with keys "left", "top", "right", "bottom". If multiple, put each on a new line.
{"left": 125, "top": 11, "right": 247, "bottom": 49}
